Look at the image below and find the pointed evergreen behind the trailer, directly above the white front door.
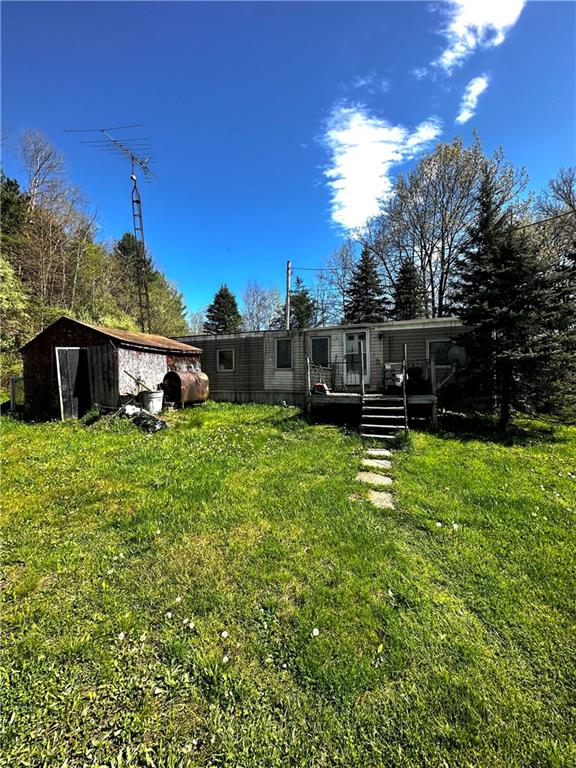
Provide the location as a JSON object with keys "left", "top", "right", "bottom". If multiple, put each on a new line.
{"left": 344, "top": 248, "right": 387, "bottom": 323}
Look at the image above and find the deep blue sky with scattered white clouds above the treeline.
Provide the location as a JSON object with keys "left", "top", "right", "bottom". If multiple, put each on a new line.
{"left": 2, "top": 0, "right": 576, "bottom": 310}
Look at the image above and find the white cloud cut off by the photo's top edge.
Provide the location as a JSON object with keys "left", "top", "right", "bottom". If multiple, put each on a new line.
{"left": 434, "top": 0, "right": 526, "bottom": 74}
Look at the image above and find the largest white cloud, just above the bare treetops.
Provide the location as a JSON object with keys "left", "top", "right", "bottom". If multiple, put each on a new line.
{"left": 324, "top": 106, "right": 442, "bottom": 229}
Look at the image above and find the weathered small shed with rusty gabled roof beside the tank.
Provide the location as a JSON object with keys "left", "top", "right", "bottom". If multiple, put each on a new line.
{"left": 21, "top": 317, "right": 202, "bottom": 419}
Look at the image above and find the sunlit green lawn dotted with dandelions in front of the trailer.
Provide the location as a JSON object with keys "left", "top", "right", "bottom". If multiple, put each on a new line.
{"left": 0, "top": 404, "right": 576, "bottom": 768}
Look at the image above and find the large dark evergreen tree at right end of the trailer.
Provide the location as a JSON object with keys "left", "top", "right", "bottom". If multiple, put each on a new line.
{"left": 458, "top": 168, "right": 576, "bottom": 429}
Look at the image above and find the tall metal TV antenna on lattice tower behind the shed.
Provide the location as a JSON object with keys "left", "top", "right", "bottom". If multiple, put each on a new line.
{"left": 64, "top": 124, "right": 155, "bottom": 332}
